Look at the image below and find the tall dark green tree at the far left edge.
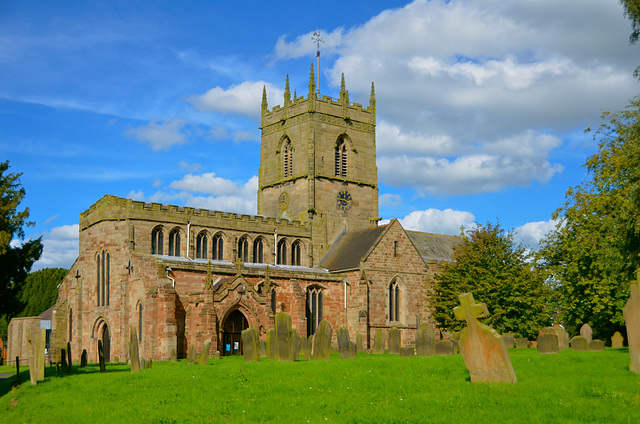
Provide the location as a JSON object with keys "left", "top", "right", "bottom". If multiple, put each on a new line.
{"left": 0, "top": 161, "right": 42, "bottom": 339}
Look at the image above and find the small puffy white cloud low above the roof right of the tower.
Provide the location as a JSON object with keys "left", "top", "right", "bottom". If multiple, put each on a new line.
{"left": 399, "top": 209, "right": 476, "bottom": 236}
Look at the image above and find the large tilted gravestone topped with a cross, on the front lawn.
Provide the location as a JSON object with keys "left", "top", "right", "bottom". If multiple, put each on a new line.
{"left": 453, "top": 293, "right": 518, "bottom": 383}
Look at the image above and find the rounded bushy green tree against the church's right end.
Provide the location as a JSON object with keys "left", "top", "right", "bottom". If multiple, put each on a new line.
{"left": 433, "top": 223, "right": 554, "bottom": 337}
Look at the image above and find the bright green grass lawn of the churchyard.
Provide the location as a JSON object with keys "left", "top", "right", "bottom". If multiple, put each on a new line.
{"left": 0, "top": 349, "right": 640, "bottom": 424}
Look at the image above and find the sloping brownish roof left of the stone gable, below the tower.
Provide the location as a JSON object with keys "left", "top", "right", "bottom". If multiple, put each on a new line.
{"left": 318, "top": 225, "right": 389, "bottom": 271}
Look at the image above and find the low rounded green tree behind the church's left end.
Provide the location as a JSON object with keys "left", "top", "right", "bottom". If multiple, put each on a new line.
{"left": 19, "top": 268, "right": 69, "bottom": 317}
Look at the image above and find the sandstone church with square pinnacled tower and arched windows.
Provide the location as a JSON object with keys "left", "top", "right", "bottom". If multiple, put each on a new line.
{"left": 42, "top": 67, "right": 460, "bottom": 361}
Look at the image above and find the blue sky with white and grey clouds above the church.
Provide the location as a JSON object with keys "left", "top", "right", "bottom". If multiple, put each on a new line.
{"left": 0, "top": 0, "right": 640, "bottom": 269}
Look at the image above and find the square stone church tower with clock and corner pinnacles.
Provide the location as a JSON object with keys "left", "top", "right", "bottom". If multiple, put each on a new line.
{"left": 258, "top": 65, "right": 380, "bottom": 265}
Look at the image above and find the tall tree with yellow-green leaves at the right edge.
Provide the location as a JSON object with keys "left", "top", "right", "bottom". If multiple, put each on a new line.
{"left": 540, "top": 98, "right": 640, "bottom": 340}
